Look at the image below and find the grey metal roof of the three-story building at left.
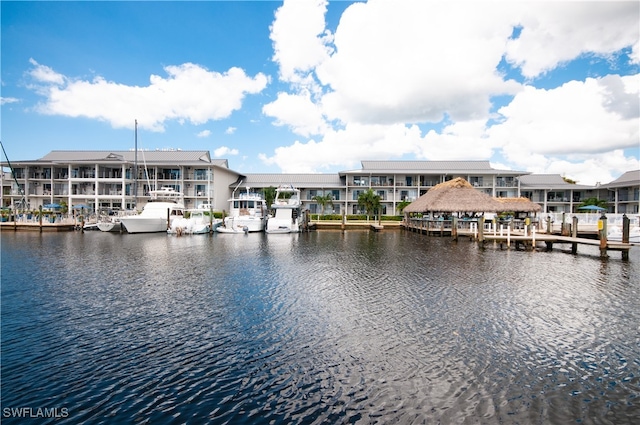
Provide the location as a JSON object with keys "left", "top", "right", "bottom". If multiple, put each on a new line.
{"left": 38, "top": 150, "right": 229, "bottom": 168}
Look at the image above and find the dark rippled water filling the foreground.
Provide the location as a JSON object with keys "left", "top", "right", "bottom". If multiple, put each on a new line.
{"left": 0, "top": 231, "right": 640, "bottom": 424}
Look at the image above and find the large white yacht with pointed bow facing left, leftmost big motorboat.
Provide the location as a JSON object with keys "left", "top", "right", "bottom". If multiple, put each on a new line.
{"left": 120, "top": 187, "right": 184, "bottom": 233}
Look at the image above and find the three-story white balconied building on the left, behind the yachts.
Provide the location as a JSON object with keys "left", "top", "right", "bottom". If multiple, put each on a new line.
{"left": 2, "top": 151, "right": 238, "bottom": 211}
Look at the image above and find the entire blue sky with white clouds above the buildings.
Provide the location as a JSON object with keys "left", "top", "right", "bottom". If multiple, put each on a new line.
{"left": 0, "top": 0, "right": 640, "bottom": 185}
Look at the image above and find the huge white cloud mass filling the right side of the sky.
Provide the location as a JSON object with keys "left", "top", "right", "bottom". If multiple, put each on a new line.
{"left": 260, "top": 0, "right": 640, "bottom": 184}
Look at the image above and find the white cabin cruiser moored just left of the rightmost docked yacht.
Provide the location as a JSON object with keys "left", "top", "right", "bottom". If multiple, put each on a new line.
{"left": 216, "top": 188, "right": 267, "bottom": 233}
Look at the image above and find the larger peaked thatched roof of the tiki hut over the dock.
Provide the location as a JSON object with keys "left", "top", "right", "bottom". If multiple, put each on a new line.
{"left": 404, "top": 177, "right": 503, "bottom": 213}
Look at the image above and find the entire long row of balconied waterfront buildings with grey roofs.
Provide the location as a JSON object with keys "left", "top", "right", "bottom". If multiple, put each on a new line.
{"left": 0, "top": 150, "right": 640, "bottom": 215}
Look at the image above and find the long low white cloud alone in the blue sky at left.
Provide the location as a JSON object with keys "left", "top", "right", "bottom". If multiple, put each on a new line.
{"left": 30, "top": 61, "right": 268, "bottom": 131}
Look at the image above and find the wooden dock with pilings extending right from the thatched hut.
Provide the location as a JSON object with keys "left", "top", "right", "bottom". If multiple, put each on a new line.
{"left": 402, "top": 217, "right": 633, "bottom": 260}
